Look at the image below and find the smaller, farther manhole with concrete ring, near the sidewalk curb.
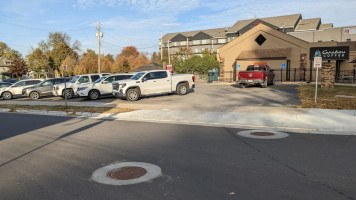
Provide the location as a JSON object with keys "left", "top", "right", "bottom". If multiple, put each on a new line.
{"left": 237, "top": 130, "right": 289, "bottom": 139}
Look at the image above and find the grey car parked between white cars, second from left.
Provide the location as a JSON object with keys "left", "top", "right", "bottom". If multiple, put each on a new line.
{"left": 22, "top": 77, "right": 70, "bottom": 99}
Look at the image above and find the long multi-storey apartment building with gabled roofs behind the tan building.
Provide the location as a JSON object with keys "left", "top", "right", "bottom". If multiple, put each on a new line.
{"left": 160, "top": 14, "right": 332, "bottom": 55}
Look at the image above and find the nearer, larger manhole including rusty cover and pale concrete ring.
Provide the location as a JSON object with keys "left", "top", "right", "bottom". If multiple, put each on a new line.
{"left": 92, "top": 162, "right": 162, "bottom": 185}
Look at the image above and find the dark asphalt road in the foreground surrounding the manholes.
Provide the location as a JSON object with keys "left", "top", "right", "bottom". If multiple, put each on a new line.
{"left": 0, "top": 113, "right": 356, "bottom": 200}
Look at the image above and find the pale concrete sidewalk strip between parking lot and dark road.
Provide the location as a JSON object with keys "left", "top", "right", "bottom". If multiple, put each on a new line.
{"left": 0, "top": 101, "right": 356, "bottom": 135}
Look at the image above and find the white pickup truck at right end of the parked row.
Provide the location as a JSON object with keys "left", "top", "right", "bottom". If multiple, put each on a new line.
{"left": 112, "top": 70, "right": 195, "bottom": 101}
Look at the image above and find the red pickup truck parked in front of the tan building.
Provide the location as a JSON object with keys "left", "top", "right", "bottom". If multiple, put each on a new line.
{"left": 237, "top": 65, "right": 274, "bottom": 88}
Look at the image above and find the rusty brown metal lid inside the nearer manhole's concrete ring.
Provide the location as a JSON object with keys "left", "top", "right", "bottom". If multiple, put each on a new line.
{"left": 107, "top": 167, "right": 147, "bottom": 180}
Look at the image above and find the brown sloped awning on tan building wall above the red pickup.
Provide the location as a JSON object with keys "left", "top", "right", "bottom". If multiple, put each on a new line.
{"left": 236, "top": 48, "right": 291, "bottom": 60}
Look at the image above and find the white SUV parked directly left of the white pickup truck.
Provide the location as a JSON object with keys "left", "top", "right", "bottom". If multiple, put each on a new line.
{"left": 77, "top": 73, "right": 134, "bottom": 100}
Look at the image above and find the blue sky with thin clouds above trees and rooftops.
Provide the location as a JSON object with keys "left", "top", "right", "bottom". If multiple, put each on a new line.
{"left": 0, "top": 0, "right": 356, "bottom": 56}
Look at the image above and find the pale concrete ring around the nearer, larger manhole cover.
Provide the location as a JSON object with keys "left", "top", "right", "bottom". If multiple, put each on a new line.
{"left": 92, "top": 162, "right": 162, "bottom": 185}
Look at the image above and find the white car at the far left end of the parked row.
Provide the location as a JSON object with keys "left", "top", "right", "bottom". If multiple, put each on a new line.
{"left": 0, "top": 79, "right": 42, "bottom": 100}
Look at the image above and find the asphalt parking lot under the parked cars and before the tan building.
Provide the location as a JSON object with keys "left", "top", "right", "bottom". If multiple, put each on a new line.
{"left": 0, "top": 82, "right": 300, "bottom": 112}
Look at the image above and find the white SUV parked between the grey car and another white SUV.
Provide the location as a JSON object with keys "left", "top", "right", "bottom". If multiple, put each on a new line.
{"left": 52, "top": 73, "right": 109, "bottom": 99}
